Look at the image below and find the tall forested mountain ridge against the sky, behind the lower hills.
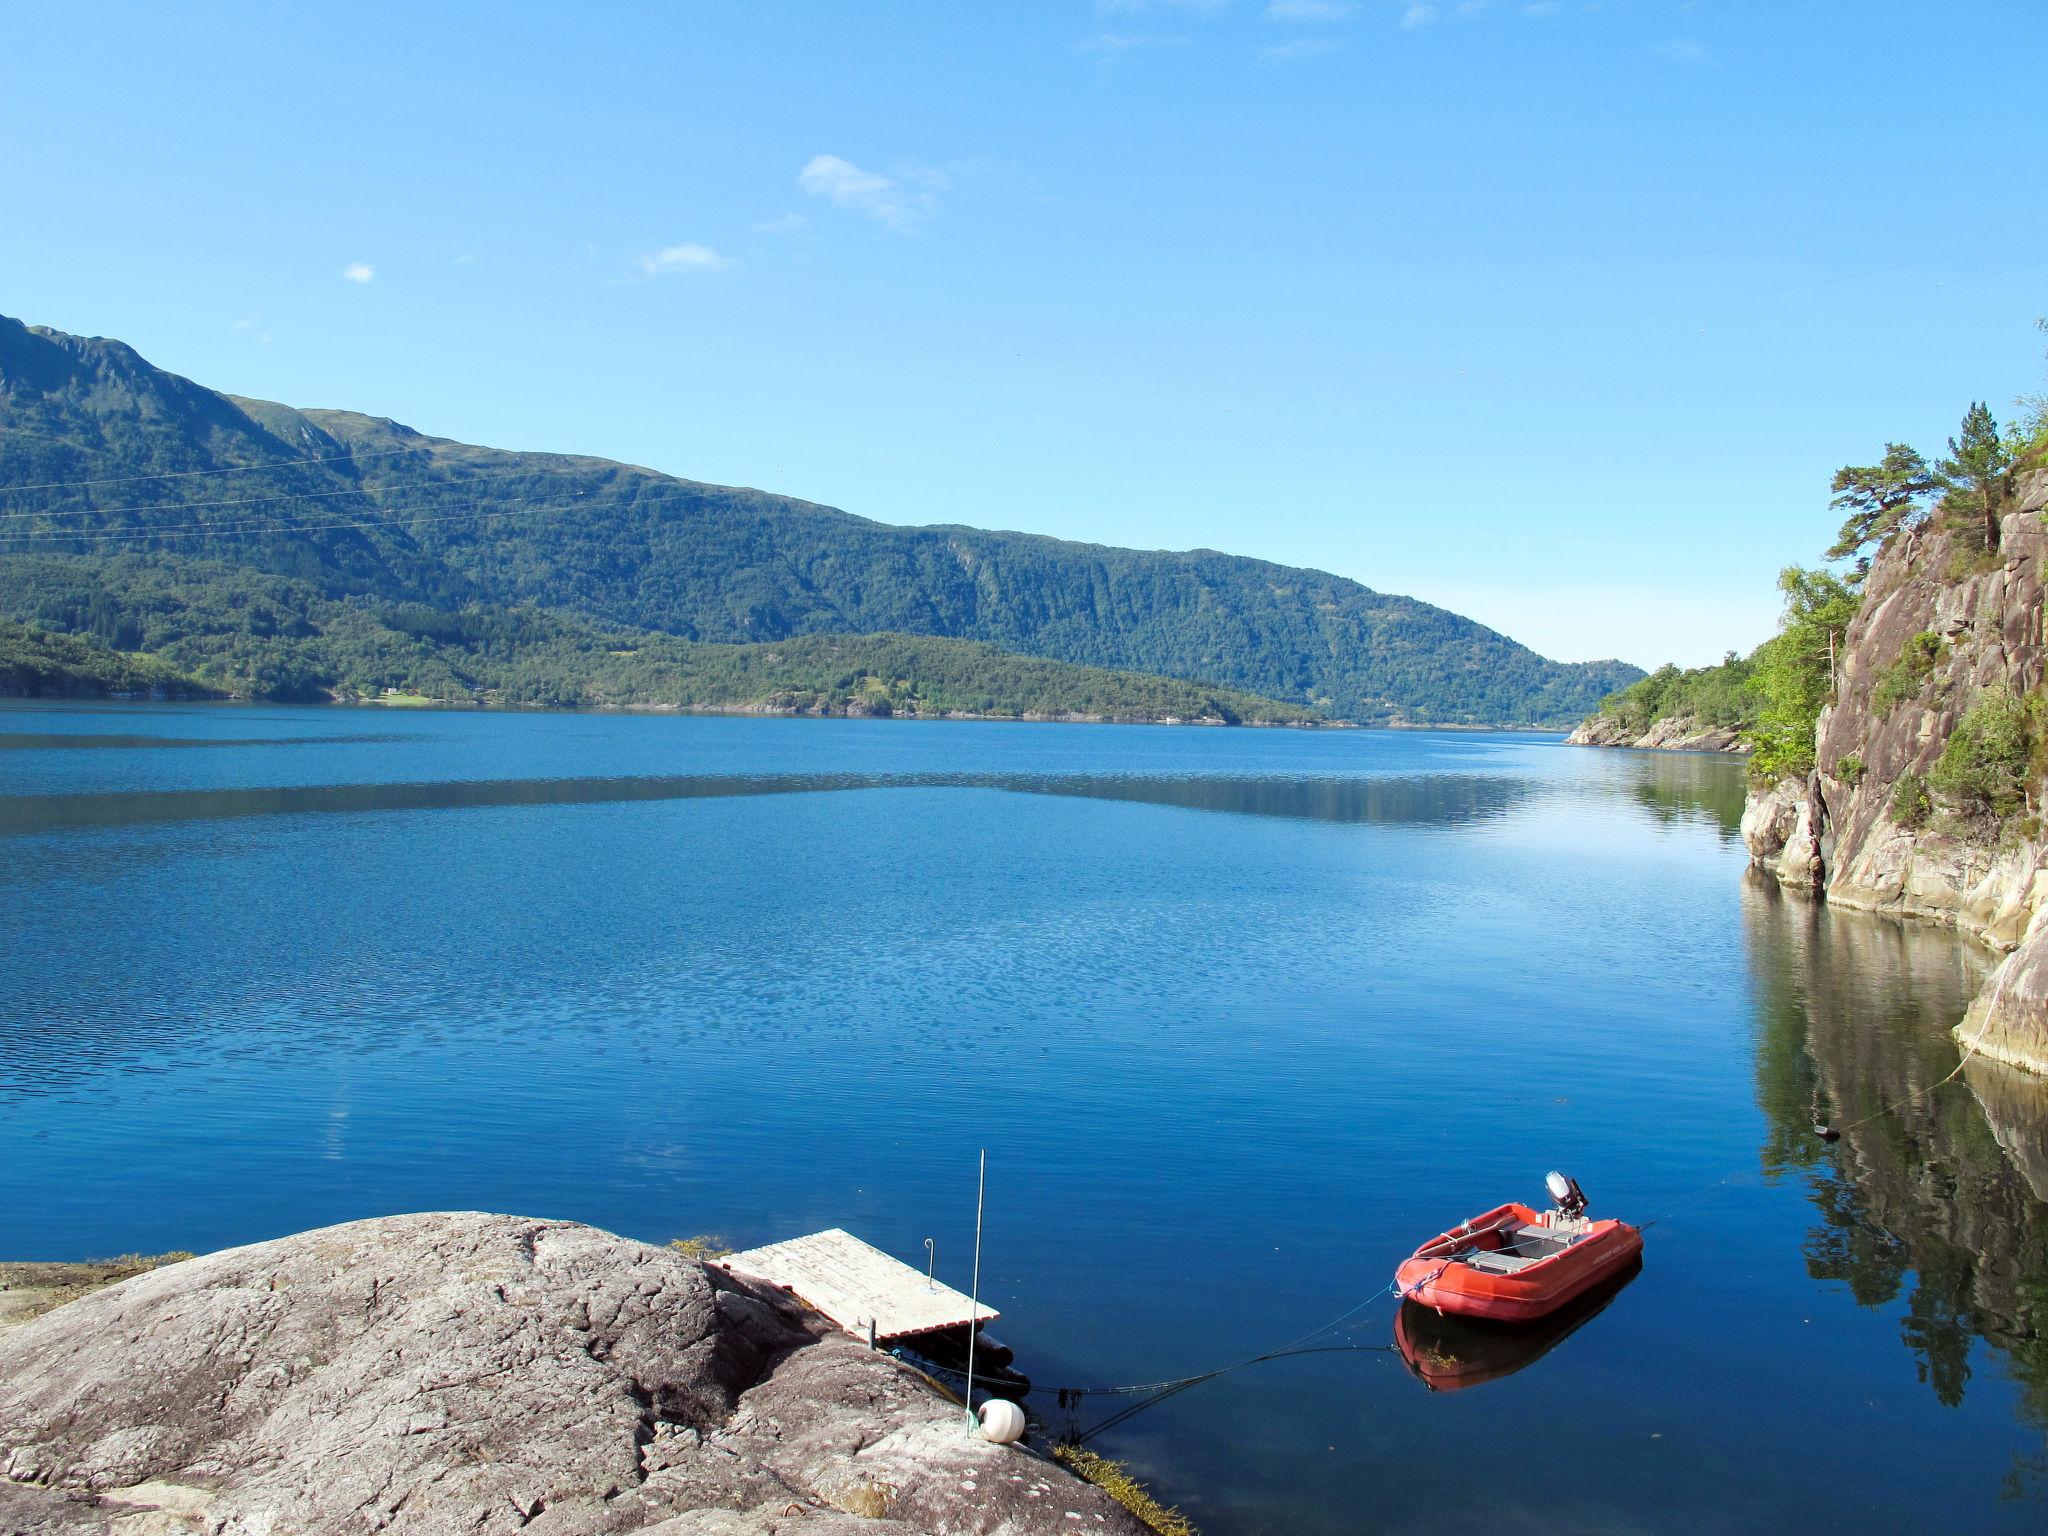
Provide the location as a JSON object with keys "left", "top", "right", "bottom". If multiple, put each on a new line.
{"left": 0, "top": 319, "right": 1640, "bottom": 725}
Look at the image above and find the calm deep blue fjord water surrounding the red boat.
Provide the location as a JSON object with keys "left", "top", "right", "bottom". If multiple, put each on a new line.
{"left": 0, "top": 705, "right": 2048, "bottom": 1536}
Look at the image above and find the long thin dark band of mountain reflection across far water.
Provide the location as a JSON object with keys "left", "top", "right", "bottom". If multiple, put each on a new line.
{"left": 0, "top": 774, "right": 1536, "bottom": 834}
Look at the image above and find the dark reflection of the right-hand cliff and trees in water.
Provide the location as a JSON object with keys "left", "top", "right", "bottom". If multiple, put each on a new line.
{"left": 1743, "top": 874, "right": 2048, "bottom": 1479}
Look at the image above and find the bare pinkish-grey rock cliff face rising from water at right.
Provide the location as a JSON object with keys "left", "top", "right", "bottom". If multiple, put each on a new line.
{"left": 1743, "top": 471, "right": 2048, "bottom": 1073}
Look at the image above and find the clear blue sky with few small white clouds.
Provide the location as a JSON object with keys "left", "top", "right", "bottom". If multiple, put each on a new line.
{"left": 0, "top": 0, "right": 2048, "bottom": 666}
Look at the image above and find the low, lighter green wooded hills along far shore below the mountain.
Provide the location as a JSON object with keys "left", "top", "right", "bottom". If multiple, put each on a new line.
{"left": 0, "top": 569, "right": 1319, "bottom": 725}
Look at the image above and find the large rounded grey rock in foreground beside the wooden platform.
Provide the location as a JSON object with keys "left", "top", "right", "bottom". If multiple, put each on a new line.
{"left": 0, "top": 1212, "right": 1143, "bottom": 1536}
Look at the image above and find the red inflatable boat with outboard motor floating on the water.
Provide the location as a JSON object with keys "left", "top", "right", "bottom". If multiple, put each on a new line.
{"left": 1395, "top": 1174, "right": 1642, "bottom": 1323}
